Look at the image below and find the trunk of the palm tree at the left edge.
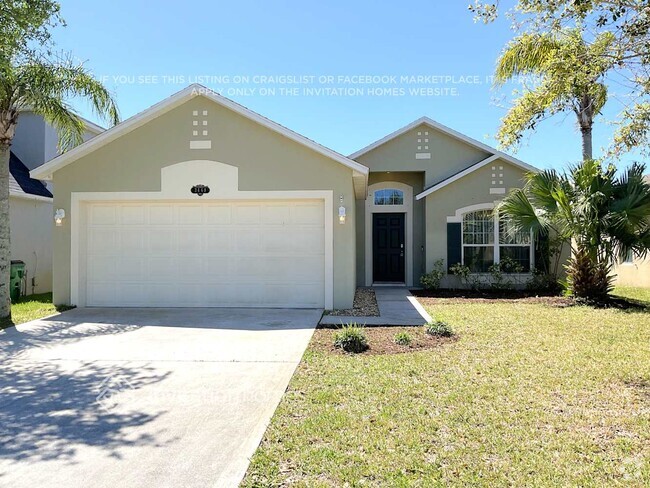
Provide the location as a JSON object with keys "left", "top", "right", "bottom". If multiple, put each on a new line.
{"left": 0, "top": 143, "right": 11, "bottom": 318}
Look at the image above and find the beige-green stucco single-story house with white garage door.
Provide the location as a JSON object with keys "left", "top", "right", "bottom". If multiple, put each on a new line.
{"left": 32, "top": 85, "right": 535, "bottom": 309}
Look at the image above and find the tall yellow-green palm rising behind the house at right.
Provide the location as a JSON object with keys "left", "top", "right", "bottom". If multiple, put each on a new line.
{"left": 495, "top": 27, "right": 615, "bottom": 160}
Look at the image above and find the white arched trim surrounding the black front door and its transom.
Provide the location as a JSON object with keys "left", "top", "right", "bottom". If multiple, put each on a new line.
{"left": 365, "top": 181, "right": 413, "bottom": 286}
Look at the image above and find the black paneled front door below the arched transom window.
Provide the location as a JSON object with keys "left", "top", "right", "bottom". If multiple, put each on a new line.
{"left": 372, "top": 213, "right": 405, "bottom": 283}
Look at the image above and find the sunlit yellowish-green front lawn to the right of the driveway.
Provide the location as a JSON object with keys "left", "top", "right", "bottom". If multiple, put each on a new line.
{"left": 243, "top": 290, "right": 650, "bottom": 487}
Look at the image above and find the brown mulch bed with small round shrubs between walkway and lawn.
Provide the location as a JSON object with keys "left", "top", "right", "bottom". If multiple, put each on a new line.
{"left": 311, "top": 327, "right": 458, "bottom": 355}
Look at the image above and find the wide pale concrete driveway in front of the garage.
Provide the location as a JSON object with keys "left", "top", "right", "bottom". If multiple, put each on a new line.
{"left": 0, "top": 309, "right": 321, "bottom": 488}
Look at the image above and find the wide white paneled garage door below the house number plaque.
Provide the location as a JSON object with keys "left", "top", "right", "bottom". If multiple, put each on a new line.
{"left": 82, "top": 200, "right": 325, "bottom": 308}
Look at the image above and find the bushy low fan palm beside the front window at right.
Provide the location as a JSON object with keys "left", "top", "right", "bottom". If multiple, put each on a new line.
{"left": 498, "top": 159, "right": 650, "bottom": 300}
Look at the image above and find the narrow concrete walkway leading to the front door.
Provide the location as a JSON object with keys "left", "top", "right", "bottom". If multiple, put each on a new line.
{"left": 320, "top": 286, "right": 431, "bottom": 325}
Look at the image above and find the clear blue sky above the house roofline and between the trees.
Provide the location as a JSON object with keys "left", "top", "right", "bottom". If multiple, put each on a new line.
{"left": 55, "top": 0, "right": 638, "bottom": 168}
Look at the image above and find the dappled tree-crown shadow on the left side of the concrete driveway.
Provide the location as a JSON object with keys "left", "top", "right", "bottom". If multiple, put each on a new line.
{"left": 0, "top": 361, "right": 169, "bottom": 464}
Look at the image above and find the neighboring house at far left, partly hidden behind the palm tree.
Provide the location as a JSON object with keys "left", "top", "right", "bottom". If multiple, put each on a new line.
{"left": 9, "top": 110, "right": 104, "bottom": 295}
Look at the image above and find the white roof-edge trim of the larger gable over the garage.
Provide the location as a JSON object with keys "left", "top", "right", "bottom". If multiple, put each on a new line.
{"left": 32, "top": 84, "right": 368, "bottom": 195}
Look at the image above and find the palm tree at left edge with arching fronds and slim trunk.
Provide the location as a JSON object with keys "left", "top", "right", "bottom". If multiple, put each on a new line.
{"left": 0, "top": 56, "right": 119, "bottom": 317}
